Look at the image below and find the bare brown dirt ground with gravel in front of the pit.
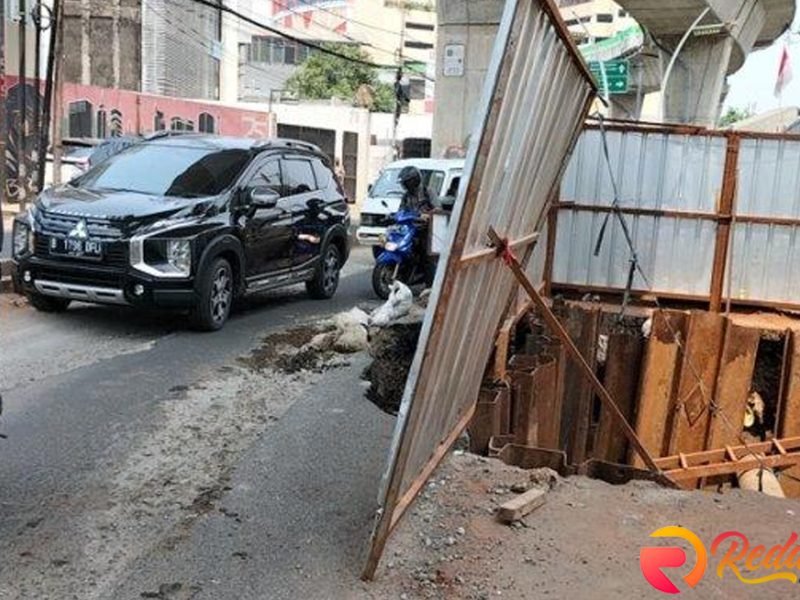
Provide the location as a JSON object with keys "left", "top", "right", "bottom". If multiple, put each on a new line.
{"left": 373, "top": 452, "right": 800, "bottom": 600}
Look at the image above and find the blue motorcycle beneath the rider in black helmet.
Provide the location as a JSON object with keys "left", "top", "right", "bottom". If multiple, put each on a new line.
{"left": 372, "top": 210, "right": 436, "bottom": 300}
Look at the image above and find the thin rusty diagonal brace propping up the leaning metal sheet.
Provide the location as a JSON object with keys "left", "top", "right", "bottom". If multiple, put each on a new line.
{"left": 489, "top": 227, "right": 661, "bottom": 473}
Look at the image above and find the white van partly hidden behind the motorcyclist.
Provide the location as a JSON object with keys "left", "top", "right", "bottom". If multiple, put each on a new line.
{"left": 356, "top": 158, "right": 464, "bottom": 246}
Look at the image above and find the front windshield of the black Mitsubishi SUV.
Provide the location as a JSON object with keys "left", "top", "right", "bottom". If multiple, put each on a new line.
{"left": 71, "top": 143, "right": 251, "bottom": 198}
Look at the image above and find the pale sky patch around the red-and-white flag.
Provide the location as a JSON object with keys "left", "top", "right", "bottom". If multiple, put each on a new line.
{"left": 725, "top": 12, "right": 800, "bottom": 113}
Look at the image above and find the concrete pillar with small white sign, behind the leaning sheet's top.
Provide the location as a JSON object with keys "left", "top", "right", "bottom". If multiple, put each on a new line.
{"left": 432, "top": 0, "right": 505, "bottom": 157}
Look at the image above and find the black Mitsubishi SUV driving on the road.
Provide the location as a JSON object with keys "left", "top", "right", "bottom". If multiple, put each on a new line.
{"left": 13, "top": 134, "right": 350, "bottom": 330}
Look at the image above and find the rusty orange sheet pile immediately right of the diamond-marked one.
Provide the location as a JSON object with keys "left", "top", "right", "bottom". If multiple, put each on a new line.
{"left": 705, "top": 323, "right": 761, "bottom": 450}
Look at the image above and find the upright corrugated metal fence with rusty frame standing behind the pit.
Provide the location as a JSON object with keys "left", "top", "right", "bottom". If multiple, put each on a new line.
{"left": 551, "top": 124, "right": 800, "bottom": 310}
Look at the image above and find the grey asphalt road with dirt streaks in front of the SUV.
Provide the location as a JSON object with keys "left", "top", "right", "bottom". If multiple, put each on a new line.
{"left": 0, "top": 249, "right": 393, "bottom": 599}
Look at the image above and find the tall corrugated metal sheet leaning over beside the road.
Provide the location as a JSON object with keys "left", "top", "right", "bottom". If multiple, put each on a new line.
{"left": 364, "top": 0, "right": 595, "bottom": 578}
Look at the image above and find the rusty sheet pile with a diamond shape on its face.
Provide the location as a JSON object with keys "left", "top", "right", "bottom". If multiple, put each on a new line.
{"left": 670, "top": 311, "right": 726, "bottom": 454}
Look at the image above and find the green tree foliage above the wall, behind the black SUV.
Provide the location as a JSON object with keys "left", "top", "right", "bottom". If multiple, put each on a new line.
{"left": 286, "top": 44, "right": 395, "bottom": 112}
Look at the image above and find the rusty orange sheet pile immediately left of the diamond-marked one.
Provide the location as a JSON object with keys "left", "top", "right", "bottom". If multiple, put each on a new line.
{"left": 630, "top": 311, "right": 686, "bottom": 467}
